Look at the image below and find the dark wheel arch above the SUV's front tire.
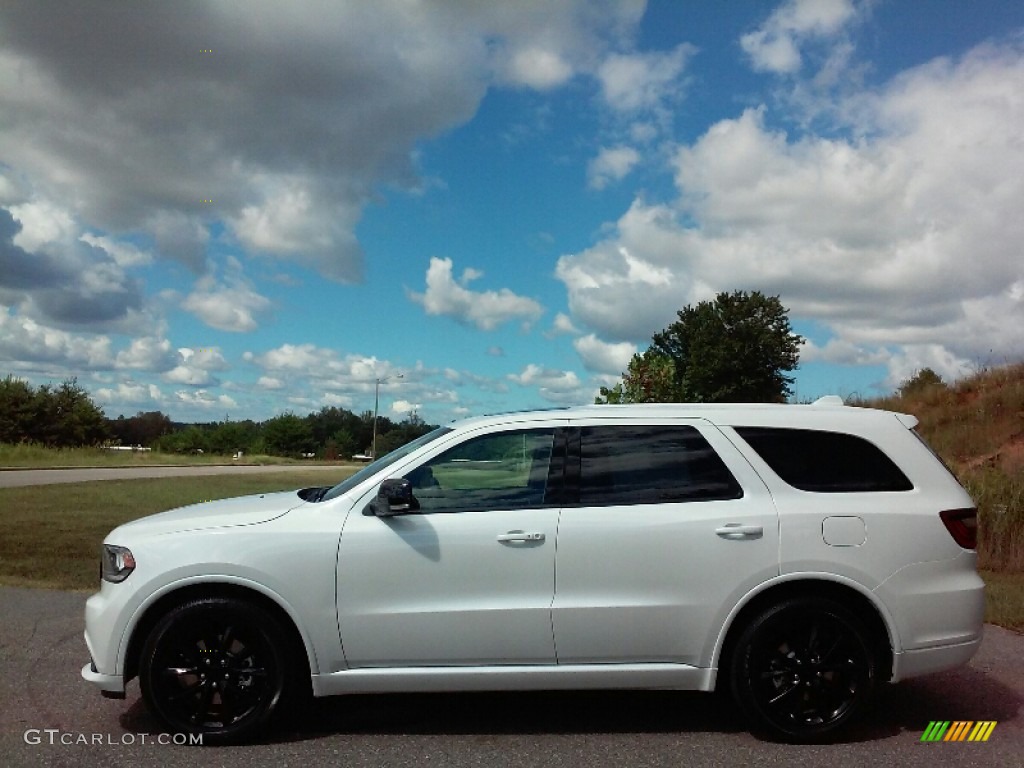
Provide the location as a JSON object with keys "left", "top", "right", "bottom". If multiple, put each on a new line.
{"left": 124, "top": 578, "right": 317, "bottom": 682}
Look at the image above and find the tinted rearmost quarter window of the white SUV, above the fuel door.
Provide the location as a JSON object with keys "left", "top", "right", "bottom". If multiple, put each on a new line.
{"left": 735, "top": 427, "right": 913, "bottom": 494}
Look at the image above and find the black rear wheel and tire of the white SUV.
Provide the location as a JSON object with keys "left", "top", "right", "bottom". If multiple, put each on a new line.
{"left": 730, "top": 598, "right": 878, "bottom": 743}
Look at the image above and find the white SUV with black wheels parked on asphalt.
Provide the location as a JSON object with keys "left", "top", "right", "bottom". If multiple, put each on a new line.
{"left": 82, "top": 398, "right": 983, "bottom": 743}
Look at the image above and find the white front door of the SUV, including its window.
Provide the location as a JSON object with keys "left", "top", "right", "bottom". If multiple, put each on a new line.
{"left": 338, "top": 423, "right": 561, "bottom": 668}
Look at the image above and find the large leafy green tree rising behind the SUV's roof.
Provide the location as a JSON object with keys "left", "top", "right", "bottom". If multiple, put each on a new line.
{"left": 597, "top": 291, "right": 804, "bottom": 402}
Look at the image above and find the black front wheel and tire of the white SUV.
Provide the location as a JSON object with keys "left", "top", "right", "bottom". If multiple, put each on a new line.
{"left": 139, "top": 597, "right": 296, "bottom": 744}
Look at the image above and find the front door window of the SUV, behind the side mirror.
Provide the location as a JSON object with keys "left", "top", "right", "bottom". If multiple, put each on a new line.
{"left": 406, "top": 429, "right": 554, "bottom": 514}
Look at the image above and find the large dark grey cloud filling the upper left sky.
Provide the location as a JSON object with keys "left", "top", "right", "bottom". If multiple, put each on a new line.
{"left": 0, "top": 0, "right": 644, "bottom": 284}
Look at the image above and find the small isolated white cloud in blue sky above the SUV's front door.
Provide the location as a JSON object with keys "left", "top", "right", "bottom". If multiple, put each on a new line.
{"left": 410, "top": 257, "right": 544, "bottom": 331}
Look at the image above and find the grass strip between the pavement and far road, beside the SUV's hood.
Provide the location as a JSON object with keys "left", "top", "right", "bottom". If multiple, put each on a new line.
{"left": 0, "top": 468, "right": 352, "bottom": 591}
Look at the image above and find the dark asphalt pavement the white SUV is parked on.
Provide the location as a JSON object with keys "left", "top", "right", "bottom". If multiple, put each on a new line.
{"left": 0, "top": 588, "right": 1024, "bottom": 768}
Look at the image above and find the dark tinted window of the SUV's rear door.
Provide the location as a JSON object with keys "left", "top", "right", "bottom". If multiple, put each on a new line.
{"left": 580, "top": 425, "right": 743, "bottom": 506}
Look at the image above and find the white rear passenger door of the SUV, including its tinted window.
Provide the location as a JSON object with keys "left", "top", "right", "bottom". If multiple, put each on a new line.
{"left": 552, "top": 420, "right": 778, "bottom": 666}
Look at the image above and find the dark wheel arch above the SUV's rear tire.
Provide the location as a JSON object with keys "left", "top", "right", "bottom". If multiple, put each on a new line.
{"left": 712, "top": 573, "right": 899, "bottom": 688}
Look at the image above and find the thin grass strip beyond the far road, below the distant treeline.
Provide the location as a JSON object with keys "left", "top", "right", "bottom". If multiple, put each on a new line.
{"left": 0, "top": 442, "right": 352, "bottom": 469}
